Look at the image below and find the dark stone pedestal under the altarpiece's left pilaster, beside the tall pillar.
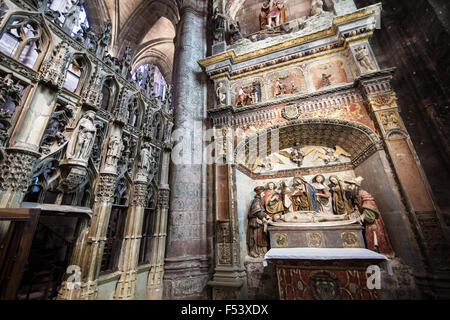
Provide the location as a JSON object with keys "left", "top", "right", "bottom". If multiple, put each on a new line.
{"left": 208, "top": 267, "right": 247, "bottom": 300}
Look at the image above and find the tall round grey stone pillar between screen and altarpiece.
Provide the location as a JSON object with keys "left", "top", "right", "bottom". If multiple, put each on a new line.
{"left": 164, "top": 1, "right": 209, "bottom": 299}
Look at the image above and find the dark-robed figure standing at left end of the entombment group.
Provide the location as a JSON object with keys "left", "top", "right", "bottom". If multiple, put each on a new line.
{"left": 247, "top": 187, "right": 271, "bottom": 258}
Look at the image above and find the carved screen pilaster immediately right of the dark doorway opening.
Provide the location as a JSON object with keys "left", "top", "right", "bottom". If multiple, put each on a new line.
{"left": 58, "top": 173, "right": 117, "bottom": 300}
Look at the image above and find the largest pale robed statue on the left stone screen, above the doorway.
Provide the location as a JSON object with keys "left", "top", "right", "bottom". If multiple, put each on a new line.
{"left": 67, "top": 111, "right": 97, "bottom": 163}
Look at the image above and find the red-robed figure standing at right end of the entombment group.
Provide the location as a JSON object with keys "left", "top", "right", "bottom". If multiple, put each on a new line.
{"left": 346, "top": 177, "right": 394, "bottom": 257}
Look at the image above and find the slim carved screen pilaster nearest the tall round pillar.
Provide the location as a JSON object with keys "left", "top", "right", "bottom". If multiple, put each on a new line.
{"left": 147, "top": 188, "right": 170, "bottom": 300}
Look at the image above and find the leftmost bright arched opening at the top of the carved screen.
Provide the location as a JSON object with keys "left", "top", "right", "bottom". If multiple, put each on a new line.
{"left": 0, "top": 16, "right": 48, "bottom": 68}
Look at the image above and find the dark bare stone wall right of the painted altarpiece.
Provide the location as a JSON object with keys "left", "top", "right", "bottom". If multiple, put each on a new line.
{"left": 355, "top": 0, "right": 450, "bottom": 226}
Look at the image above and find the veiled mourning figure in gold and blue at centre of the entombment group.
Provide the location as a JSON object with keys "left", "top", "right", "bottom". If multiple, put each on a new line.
{"left": 291, "top": 176, "right": 319, "bottom": 211}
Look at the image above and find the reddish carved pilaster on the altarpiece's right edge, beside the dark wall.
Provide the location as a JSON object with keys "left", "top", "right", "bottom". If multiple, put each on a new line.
{"left": 361, "top": 73, "right": 450, "bottom": 272}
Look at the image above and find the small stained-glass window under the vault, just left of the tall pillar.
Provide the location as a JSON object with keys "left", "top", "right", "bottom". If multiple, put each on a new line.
{"left": 132, "top": 64, "right": 167, "bottom": 100}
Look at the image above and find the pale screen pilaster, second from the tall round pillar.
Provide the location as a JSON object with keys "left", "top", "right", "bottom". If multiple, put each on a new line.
{"left": 114, "top": 181, "right": 148, "bottom": 300}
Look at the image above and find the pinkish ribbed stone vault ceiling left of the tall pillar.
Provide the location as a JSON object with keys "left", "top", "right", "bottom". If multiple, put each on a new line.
{"left": 85, "top": 0, "right": 179, "bottom": 83}
